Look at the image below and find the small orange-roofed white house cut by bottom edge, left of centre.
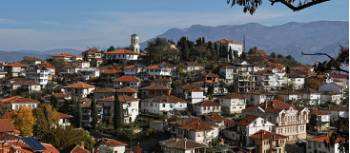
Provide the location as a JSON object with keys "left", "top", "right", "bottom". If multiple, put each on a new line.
{"left": 97, "top": 138, "right": 127, "bottom": 153}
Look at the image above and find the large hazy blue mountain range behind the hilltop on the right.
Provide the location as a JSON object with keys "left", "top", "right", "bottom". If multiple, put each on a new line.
{"left": 141, "top": 21, "right": 349, "bottom": 64}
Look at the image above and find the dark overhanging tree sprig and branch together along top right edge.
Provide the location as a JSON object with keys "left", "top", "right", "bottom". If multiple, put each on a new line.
{"left": 227, "top": 0, "right": 330, "bottom": 14}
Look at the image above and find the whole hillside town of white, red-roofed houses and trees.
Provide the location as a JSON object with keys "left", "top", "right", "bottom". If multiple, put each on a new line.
{"left": 0, "top": 34, "right": 349, "bottom": 153}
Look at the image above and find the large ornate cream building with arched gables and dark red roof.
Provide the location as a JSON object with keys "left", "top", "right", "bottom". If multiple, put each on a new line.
{"left": 244, "top": 100, "right": 309, "bottom": 142}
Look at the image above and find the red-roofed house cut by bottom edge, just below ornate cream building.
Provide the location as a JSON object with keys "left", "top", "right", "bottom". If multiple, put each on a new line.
{"left": 248, "top": 130, "right": 288, "bottom": 153}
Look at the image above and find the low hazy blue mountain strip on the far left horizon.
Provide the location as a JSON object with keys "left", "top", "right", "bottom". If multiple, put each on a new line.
{"left": 0, "top": 48, "right": 82, "bottom": 62}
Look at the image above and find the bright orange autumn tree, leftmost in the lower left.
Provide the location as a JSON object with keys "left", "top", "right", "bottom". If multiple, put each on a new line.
{"left": 13, "top": 107, "right": 35, "bottom": 136}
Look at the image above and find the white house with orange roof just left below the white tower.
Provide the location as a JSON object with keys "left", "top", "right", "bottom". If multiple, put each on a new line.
{"left": 105, "top": 49, "right": 140, "bottom": 61}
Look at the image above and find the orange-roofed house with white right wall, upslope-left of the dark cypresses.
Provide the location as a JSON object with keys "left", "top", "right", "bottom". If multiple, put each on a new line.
{"left": 64, "top": 82, "right": 95, "bottom": 98}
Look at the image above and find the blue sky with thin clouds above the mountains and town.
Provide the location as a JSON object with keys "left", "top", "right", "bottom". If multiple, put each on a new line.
{"left": 0, "top": 0, "right": 349, "bottom": 50}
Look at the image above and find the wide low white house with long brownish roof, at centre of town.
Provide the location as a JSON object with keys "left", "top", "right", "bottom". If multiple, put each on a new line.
{"left": 141, "top": 95, "right": 187, "bottom": 114}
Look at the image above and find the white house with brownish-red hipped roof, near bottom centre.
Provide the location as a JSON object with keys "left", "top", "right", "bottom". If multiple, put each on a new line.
{"left": 176, "top": 118, "right": 219, "bottom": 144}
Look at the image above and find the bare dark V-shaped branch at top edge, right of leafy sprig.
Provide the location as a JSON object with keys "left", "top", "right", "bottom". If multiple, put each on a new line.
{"left": 270, "top": 0, "right": 330, "bottom": 11}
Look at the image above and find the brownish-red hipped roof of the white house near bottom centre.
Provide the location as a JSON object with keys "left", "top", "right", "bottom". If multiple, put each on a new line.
{"left": 179, "top": 118, "right": 213, "bottom": 131}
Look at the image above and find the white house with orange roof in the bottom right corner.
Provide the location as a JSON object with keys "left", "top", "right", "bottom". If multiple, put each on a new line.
{"left": 306, "top": 135, "right": 347, "bottom": 153}
